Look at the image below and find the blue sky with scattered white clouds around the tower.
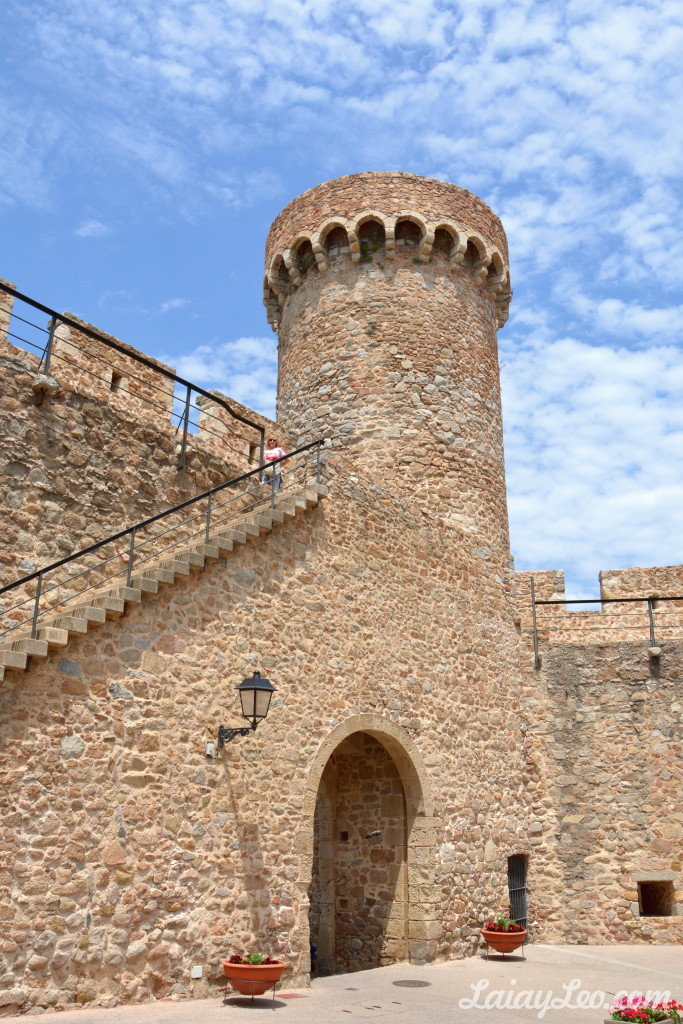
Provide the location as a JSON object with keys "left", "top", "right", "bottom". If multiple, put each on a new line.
{"left": 0, "top": 0, "right": 683, "bottom": 596}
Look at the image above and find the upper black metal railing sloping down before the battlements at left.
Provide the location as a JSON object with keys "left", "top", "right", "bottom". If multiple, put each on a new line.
{"left": 0, "top": 281, "right": 265, "bottom": 466}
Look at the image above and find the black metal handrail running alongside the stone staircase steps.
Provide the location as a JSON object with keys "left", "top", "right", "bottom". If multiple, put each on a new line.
{"left": 0, "top": 440, "right": 325, "bottom": 638}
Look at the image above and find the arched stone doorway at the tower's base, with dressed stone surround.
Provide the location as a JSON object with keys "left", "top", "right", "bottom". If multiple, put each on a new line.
{"left": 308, "top": 716, "right": 440, "bottom": 975}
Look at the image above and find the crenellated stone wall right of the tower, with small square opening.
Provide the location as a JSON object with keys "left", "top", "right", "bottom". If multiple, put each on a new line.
{"left": 515, "top": 566, "right": 683, "bottom": 943}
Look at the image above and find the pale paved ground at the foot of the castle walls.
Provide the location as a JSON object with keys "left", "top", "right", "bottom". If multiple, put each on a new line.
{"left": 4, "top": 945, "right": 683, "bottom": 1024}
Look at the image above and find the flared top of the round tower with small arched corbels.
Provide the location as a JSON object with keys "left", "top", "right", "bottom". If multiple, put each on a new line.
{"left": 263, "top": 171, "right": 512, "bottom": 331}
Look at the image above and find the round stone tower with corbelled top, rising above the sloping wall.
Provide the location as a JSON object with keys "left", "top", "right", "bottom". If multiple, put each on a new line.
{"left": 264, "top": 171, "right": 511, "bottom": 555}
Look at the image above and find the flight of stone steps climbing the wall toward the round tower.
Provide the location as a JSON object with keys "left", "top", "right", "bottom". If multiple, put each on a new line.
{"left": 0, "top": 483, "right": 328, "bottom": 682}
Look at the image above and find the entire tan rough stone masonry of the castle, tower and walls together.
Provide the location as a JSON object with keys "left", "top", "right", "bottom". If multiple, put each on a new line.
{"left": 0, "top": 172, "right": 683, "bottom": 1014}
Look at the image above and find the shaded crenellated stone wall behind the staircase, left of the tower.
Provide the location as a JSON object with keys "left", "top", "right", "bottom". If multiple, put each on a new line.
{"left": 0, "top": 303, "right": 272, "bottom": 606}
